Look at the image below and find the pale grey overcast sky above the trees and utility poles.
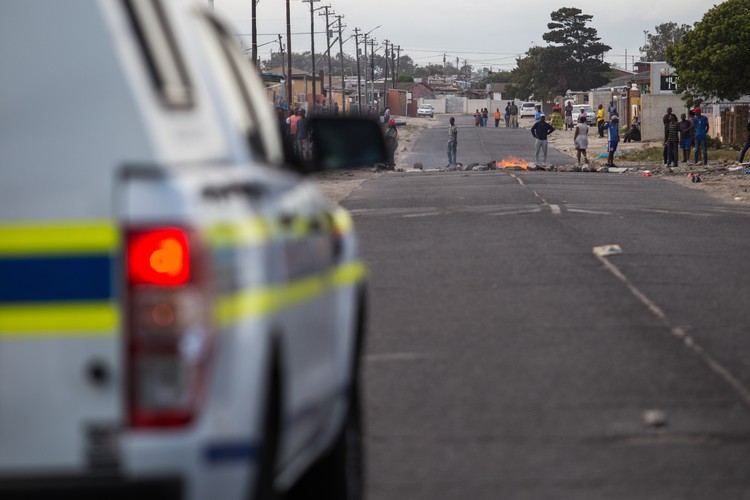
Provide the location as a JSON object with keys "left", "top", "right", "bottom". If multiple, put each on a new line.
{"left": 206, "top": 0, "right": 721, "bottom": 70}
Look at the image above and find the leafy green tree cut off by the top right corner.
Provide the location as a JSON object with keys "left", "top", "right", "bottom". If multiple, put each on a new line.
{"left": 667, "top": 0, "right": 750, "bottom": 104}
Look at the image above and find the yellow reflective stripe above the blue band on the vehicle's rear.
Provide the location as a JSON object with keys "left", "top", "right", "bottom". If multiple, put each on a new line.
{"left": 0, "top": 221, "right": 120, "bottom": 255}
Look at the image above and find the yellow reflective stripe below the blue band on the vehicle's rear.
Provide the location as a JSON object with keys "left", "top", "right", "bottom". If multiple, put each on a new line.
{"left": 0, "top": 302, "right": 120, "bottom": 338}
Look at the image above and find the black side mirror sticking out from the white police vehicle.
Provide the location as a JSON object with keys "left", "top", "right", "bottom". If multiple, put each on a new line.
{"left": 305, "top": 117, "right": 387, "bottom": 172}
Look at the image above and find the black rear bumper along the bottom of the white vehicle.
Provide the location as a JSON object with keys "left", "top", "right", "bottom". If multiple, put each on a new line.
{"left": 0, "top": 475, "right": 183, "bottom": 500}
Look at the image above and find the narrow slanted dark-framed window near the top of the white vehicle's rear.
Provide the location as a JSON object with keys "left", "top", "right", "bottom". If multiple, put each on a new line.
{"left": 124, "top": 0, "right": 193, "bottom": 108}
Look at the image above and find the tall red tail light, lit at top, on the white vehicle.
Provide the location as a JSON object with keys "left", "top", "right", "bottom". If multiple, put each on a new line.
{"left": 125, "top": 227, "right": 213, "bottom": 428}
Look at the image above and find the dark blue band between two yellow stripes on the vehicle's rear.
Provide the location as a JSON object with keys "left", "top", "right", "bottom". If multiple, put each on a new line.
{"left": 0, "top": 255, "right": 114, "bottom": 303}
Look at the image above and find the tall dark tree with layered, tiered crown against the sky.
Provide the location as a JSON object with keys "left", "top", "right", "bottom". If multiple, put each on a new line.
{"left": 512, "top": 7, "right": 611, "bottom": 99}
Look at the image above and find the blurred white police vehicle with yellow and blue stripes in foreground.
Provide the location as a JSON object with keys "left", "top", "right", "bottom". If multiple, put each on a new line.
{"left": 0, "top": 0, "right": 384, "bottom": 499}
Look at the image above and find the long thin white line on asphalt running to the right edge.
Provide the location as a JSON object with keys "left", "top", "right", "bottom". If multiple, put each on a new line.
{"left": 596, "top": 255, "right": 750, "bottom": 407}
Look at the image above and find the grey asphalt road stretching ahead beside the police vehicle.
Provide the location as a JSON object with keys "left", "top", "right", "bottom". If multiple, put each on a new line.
{"left": 344, "top": 115, "right": 750, "bottom": 500}
